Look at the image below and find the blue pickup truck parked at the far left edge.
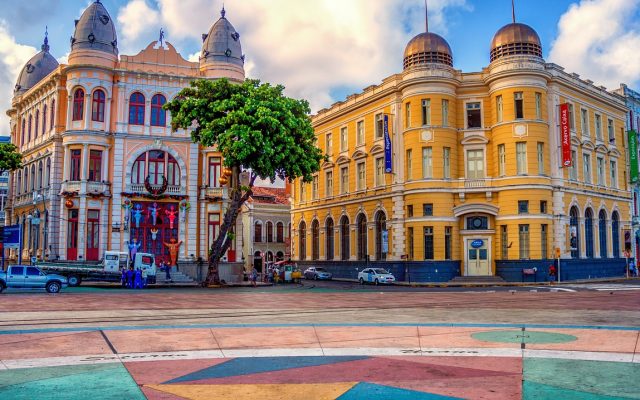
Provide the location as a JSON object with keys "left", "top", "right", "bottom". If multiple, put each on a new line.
{"left": 0, "top": 265, "right": 67, "bottom": 293}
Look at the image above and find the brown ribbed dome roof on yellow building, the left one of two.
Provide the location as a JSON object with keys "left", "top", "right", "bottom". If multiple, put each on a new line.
{"left": 403, "top": 32, "right": 453, "bottom": 69}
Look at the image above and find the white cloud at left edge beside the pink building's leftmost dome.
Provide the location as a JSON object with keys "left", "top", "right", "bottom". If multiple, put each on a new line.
{"left": 0, "top": 20, "right": 38, "bottom": 134}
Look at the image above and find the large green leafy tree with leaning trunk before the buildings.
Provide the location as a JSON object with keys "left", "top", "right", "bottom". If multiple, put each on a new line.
{"left": 164, "top": 79, "right": 324, "bottom": 285}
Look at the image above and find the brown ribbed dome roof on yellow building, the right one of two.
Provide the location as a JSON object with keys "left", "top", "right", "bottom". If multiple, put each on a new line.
{"left": 491, "top": 22, "right": 542, "bottom": 62}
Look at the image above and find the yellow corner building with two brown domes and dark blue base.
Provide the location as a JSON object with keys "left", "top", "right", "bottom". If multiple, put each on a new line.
{"left": 292, "top": 22, "right": 631, "bottom": 281}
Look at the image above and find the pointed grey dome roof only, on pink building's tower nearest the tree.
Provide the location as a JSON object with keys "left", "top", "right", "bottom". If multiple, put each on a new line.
{"left": 200, "top": 9, "right": 244, "bottom": 68}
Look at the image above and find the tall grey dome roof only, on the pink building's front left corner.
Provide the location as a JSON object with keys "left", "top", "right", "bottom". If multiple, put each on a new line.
{"left": 71, "top": 0, "right": 118, "bottom": 56}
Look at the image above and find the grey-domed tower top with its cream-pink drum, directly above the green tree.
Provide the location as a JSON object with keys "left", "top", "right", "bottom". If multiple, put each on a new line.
{"left": 200, "top": 8, "right": 245, "bottom": 81}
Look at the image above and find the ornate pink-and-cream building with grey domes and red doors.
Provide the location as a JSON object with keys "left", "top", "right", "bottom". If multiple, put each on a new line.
{"left": 8, "top": 1, "right": 244, "bottom": 261}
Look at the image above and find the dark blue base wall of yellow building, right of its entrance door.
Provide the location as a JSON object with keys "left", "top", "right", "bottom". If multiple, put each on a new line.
{"left": 496, "top": 258, "right": 626, "bottom": 282}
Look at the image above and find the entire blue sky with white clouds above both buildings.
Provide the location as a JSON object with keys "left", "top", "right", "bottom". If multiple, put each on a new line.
{"left": 0, "top": 0, "right": 640, "bottom": 135}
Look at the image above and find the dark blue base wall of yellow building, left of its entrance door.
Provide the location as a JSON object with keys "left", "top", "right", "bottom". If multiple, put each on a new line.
{"left": 297, "top": 261, "right": 460, "bottom": 282}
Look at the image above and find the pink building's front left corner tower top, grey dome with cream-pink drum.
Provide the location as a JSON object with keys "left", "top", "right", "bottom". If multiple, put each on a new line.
{"left": 69, "top": 0, "right": 118, "bottom": 67}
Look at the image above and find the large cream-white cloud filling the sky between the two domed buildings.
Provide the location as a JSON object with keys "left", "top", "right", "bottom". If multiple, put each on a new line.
{"left": 118, "top": 0, "right": 470, "bottom": 110}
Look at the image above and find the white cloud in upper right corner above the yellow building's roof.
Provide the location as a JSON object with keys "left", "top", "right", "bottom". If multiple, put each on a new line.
{"left": 549, "top": 0, "right": 640, "bottom": 89}
